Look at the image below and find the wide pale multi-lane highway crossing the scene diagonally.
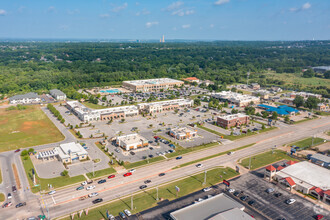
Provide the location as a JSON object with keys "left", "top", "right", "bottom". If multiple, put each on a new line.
{"left": 0, "top": 117, "right": 330, "bottom": 219}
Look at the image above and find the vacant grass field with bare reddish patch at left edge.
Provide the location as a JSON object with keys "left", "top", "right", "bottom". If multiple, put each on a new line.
{"left": 0, "top": 106, "right": 64, "bottom": 152}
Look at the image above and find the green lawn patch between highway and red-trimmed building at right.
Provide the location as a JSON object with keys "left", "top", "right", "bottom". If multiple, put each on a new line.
{"left": 240, "top": 150, "right": 297, "bottom": 170}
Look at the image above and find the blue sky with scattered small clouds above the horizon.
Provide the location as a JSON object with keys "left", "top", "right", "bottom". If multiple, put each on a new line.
{"left": 0, "top": 0, "right": 330, "bottom": 40}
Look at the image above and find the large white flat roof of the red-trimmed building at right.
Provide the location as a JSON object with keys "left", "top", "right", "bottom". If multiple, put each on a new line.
{"left": 277, "top": 161, "right": 330, "bottom": 190}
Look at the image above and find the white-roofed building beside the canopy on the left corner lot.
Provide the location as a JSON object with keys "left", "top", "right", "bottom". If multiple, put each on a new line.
{"left": 54, "top": 142, "right": 88, "bottom": 163}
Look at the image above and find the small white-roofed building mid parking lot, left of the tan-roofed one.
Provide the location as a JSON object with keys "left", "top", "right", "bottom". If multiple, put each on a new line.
{"left": 116, "top": 133, "right": 149, "bottom": 151}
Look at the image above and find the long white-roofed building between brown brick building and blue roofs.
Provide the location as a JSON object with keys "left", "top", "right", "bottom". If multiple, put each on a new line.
{"left": 211, "top": 91, "right": 260, "bottom": 107}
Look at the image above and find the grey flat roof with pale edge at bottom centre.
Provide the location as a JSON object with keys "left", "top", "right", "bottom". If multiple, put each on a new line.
{"left": 170, "top": 193, "right": 245, "bottom": 220}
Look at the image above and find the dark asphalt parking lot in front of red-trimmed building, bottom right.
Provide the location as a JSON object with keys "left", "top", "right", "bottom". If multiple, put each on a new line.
{"left": 226, "top": 169, "right": 330, "bottom": 219}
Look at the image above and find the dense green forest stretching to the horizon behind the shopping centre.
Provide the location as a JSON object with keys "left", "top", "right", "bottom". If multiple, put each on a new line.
{"left": 0, "top": 41, "right": 330, "bottom": 96}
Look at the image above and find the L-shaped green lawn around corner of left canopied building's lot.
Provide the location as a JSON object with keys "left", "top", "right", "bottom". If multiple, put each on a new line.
{"left": 21, "top": 156, "right": 86, "bottom": 193}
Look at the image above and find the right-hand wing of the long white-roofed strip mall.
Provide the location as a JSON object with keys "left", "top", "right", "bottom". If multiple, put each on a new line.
{"left": 137, "top": 99, "right": 194, "bottom": 113}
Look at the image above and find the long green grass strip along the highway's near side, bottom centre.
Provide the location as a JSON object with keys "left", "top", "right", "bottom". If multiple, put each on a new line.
{"left": 62, "top": 168, "right": 237, "bottom": 220}
